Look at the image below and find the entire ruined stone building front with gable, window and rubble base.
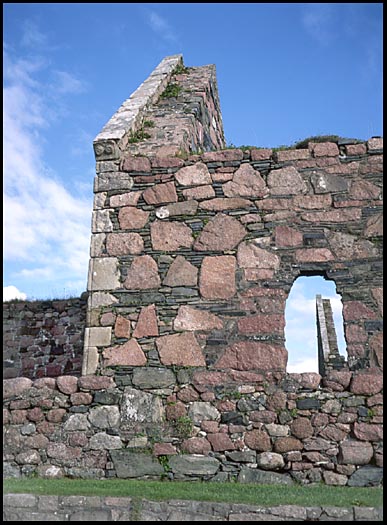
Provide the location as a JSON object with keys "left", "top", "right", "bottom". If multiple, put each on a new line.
{"left": 4, "top": 56, "right": 383, "bottom": 486}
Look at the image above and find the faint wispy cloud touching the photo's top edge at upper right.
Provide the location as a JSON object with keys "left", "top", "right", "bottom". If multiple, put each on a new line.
{"left": 302, "top": 4, "right": 335, "bottom": 46}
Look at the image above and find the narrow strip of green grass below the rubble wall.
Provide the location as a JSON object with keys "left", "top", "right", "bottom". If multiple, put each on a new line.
{"left": 3, "top": 478, "right": 383, "bottom": 507}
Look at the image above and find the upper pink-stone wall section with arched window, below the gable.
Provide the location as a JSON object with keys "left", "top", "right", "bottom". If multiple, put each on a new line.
{"left": 83, "top": 139, "right": 383, "bottom": 376}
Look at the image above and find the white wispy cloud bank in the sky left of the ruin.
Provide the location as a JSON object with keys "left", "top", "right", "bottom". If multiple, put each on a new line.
{"left": 3, "top": 42, "right": 91, "bottom": 296}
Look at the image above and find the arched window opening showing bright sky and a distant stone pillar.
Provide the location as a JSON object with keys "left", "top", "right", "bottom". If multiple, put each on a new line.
{"left": 285, "top": 275, "right": 347, "bottom": 373}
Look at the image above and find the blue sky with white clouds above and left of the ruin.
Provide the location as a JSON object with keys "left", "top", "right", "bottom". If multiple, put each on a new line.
{"left": 3, "top": 3, "right": 383, "bottom": 372}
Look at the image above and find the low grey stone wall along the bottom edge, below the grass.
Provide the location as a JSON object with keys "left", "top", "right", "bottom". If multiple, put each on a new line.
{"left": 3, "top": 494, "right": 383, "bottom": 522}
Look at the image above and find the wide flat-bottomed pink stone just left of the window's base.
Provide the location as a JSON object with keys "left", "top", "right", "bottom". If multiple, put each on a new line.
{"left": 214, "top": 341, "right": 287, "bottom": 371}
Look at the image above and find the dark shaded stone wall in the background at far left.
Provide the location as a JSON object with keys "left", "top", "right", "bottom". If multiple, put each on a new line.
{"left": 3, "top": 294, "right": 87, "bottom": 379}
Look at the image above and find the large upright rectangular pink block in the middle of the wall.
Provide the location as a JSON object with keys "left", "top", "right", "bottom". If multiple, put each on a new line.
{"left": 199, "top": 255, "right": 236, "bottom": 299}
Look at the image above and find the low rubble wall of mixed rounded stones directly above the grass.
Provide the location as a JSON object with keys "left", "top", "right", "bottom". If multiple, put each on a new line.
{"left": 3, "top": 367, "right": 383, "bottom": 486}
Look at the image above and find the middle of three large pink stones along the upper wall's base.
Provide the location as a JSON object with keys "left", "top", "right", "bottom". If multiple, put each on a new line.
{"left": 156, "top": 332, "right": 206, "bottom": 366}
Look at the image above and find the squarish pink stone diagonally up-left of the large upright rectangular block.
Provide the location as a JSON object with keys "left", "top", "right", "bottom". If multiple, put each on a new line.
{"left": 151, "top": 220, "right": 193, "bottom": 251}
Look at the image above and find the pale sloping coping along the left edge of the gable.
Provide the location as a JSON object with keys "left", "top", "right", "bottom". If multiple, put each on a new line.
{"left": 93, "top": 55, "right": 183, "bottom": 144}
